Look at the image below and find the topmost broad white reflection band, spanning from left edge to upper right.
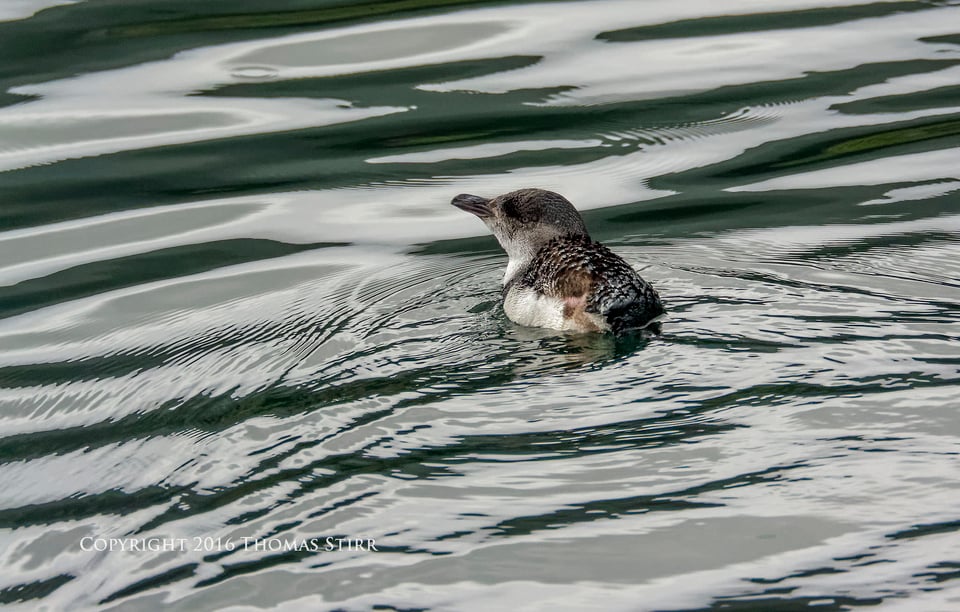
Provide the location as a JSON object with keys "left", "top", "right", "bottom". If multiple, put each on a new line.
{"left": 0, "top": 0, "right": 956, "bottom": 175}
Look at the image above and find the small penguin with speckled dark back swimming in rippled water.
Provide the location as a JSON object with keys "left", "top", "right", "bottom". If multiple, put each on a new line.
{"left": 451, "top": 189, "right": 665, "bottom": 335}
